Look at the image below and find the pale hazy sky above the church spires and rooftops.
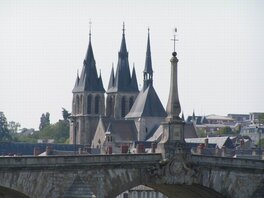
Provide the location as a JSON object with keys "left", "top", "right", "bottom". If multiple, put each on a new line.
{"left": 0, "top": 0, "right": 264, "bottom": 129}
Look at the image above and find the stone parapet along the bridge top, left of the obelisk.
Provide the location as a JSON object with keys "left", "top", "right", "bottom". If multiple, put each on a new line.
{"left": 0, "top": 154, "right": 162, "bottom": 171}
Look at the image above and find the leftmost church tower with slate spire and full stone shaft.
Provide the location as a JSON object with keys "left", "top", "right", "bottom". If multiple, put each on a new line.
{"left": 70, "top": 27, "right": 105, "bottom": 144}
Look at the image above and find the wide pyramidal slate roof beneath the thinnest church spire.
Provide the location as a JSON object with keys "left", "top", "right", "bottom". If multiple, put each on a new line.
{"left": 126, "top": 85, "right": 167, "bottom": 118}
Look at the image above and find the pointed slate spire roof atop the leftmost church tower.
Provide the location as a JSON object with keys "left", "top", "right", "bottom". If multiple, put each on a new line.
{"left": 72, "top": 35, "right": 105, "bottom": 93}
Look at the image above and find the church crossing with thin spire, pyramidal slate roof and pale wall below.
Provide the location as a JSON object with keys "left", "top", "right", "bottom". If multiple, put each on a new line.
{"left": 126, "top": 30, "right": 167, "bottom": 141}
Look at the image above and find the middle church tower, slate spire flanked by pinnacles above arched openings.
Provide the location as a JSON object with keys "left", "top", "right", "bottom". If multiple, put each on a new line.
{"left": 106, "top": 24, "right": 138, "bottom": 119}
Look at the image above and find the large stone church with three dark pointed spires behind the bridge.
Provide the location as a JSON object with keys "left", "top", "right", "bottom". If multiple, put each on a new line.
{"left": 70, "top": 24, "right": 197, "bottom": 153}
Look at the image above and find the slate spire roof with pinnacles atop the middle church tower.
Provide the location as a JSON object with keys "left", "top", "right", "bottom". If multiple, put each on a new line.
{"left": 107, "top": 26, "right": 138, "bottom": 93}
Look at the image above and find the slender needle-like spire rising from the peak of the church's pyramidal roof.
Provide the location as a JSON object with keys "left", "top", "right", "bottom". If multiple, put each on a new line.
{"left": 143, "top": 28, "right": 153, "bottom": 89}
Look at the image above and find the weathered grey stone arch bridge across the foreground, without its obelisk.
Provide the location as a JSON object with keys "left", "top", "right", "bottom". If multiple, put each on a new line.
{"left": 0, "top": 154, "right": 264, "bottom": 198}
